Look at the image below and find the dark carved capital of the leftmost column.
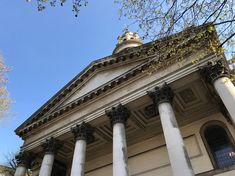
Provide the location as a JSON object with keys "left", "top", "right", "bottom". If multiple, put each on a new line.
{"left": 15, "top": 151, "right": 33, "bottom": 168}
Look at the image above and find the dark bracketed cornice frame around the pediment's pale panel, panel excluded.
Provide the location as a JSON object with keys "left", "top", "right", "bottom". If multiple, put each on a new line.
{"left": 15, "top": 24, "right": 217, "bottom": 138}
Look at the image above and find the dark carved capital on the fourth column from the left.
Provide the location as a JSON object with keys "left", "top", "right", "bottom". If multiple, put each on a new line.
{"left": 105, "top": 104, "right": 130, "bottom": 126}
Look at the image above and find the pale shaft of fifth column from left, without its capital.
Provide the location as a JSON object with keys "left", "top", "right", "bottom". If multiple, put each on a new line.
{"left": 158, "top": 102, "right": 194, "bottom": 176}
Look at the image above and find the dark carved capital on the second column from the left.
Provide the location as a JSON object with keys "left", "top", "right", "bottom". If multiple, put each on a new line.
{"left": 42, "top": 137, "right": 62, "bottom": 154}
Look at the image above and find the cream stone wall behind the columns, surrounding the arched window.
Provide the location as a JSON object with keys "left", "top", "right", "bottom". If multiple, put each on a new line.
{"left": 82, "top": 113, "right": 235, "bottom": 176}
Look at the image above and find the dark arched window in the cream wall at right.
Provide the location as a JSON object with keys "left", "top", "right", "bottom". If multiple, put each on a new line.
{"left": 202, "top": 121, "right": 235, "bottom": 168}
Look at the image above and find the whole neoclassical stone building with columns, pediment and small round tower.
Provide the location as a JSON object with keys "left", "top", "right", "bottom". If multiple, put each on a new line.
{"left": 15, "top": 25, "right": 235, "bottom": 176}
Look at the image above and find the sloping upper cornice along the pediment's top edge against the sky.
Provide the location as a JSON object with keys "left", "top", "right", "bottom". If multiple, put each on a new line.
{"left": 15, "top": 23, "right": 216, "bottom": 136}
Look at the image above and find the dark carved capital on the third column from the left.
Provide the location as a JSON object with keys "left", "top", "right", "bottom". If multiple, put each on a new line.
{"left": 71, "top": 122, "right": 94, "bottom": 143}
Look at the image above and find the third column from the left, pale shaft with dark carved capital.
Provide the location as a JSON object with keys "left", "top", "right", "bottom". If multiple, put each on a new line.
{"left": 71, "top": 122, "right": 94, "bottom": 176}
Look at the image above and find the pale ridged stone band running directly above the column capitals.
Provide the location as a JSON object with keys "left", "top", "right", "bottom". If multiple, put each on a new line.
{"left": 22, "top": 55, "right": 218, "bottom": 151}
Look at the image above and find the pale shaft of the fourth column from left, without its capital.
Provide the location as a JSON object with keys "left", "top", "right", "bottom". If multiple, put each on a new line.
{"left": 113, "top": 123, "right": 129, "bottom": 176}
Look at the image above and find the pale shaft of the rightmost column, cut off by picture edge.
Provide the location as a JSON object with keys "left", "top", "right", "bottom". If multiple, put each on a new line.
{"left": 214, "top": 77, "right": 235, "bottom": 124}
